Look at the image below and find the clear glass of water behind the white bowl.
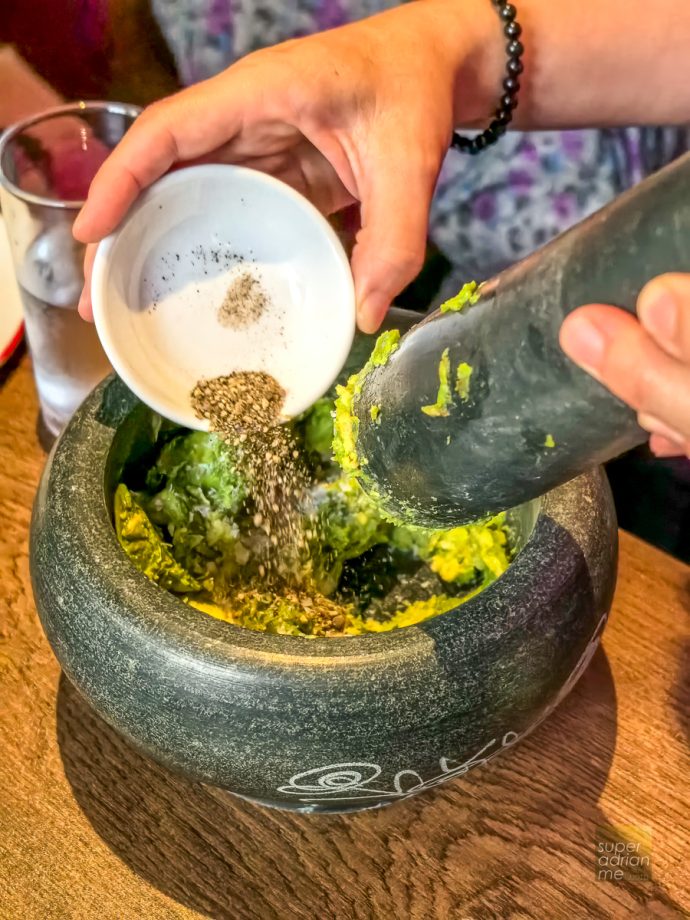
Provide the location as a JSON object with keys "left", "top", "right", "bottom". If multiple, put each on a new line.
{"left": 0, "top": 102, "right": 140, "bottom": 435}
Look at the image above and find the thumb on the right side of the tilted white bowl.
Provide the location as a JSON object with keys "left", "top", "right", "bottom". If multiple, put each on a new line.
{"left": 352, "top": 152, "right": 438, "bottom": 332}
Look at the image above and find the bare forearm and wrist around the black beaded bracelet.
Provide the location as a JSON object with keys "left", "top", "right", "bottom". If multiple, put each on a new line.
{"left": 422, "top": 0, "right": 690, "bottom": 129}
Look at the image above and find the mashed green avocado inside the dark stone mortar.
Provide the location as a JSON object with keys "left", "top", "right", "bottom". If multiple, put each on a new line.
{"left": 113, "top": 392, "right": 513, "bottom": 638}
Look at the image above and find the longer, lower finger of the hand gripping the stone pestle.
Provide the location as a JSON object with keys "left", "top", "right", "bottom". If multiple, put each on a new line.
{"left": 560, "top": 305, "right": 690, "bottom": 439}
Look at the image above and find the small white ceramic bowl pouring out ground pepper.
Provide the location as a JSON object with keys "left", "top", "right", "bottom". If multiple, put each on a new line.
{"left": 91, "top": 165, "right": 355, "bottom": 430}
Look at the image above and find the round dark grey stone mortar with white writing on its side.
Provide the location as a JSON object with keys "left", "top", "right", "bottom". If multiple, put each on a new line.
{"left": 31, "top": 310, "right": 617, "bottom": 812}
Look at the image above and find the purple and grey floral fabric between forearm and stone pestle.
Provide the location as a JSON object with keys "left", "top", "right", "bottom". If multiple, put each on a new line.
{"left": 430, "top": 128, "right": 690, "bottom": 298}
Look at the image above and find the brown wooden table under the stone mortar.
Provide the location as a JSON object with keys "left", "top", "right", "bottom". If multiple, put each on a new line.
{"left": 0, "top": 359, "right": 690, "bottom": 920}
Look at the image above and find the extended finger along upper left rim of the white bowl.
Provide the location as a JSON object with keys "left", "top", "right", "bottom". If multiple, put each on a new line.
{"left": 74, "top": 73, "right": 257, "bottom": 243}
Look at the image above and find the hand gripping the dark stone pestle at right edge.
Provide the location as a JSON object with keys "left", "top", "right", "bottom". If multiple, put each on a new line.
{"left": 560, "top": 274, "right": 690, "bottom": 457}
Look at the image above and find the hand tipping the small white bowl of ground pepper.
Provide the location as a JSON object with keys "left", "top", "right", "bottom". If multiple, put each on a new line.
{"left": 75, "top": 0, "right": 502, "bottom": 332}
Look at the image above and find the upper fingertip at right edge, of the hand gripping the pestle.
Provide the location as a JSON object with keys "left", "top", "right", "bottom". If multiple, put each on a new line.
{"left": 637, "top": 274, "right": 690, "bottom": 362}
